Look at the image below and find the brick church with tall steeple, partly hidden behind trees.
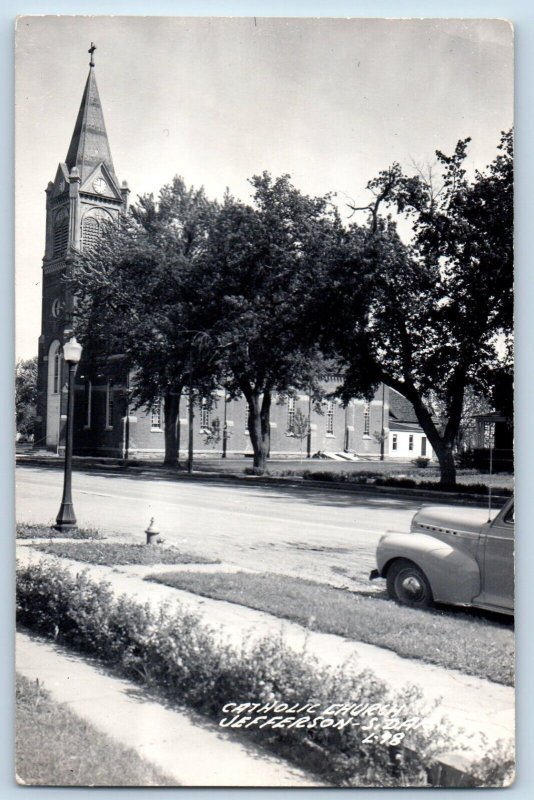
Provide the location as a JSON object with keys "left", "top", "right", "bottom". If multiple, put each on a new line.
{"left": 35, "top": 45, "right": 432, "bottom": 459}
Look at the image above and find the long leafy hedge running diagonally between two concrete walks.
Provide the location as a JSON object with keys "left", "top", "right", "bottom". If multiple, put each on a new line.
{"left": 17, "top": 562, "right": 512, "bottom": 786}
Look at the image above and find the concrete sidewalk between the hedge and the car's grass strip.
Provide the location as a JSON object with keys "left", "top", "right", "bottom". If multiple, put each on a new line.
{"left": 17, "top": 542, "right": 515, "bottom": 759}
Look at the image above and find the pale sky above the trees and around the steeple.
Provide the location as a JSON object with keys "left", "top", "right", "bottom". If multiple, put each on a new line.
{"left": 15, "top": 16, "right": 513, "bottom": 358}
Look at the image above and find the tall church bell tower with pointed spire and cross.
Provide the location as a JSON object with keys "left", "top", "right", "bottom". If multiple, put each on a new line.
{"left": 35, "top": 42, "right": 129, "bottom": 450}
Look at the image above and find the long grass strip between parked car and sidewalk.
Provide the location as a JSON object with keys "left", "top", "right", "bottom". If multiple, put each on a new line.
{"left": 146, "top": 572, "right": 514, "bottom": 685}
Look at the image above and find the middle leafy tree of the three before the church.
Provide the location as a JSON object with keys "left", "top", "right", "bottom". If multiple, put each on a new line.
{"left": 196, "top": 173, "right": 340, "bottom": 470}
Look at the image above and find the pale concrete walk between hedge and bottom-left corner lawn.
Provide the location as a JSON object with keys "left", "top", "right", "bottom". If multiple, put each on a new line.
{"left": 16, "top": 632, "right": 326, "bottom": 787}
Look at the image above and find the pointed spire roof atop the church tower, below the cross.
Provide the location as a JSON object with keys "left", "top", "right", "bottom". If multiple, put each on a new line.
{"left": 65, "top": 64, "right": 117, "bottom": 183}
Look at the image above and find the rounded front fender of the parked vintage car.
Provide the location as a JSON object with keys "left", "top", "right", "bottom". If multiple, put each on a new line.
{"left": 376, "top": 533, "right": 481, "bottom": 605}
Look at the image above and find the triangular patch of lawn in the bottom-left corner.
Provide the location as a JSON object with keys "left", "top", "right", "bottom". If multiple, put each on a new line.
{"left": 16, "top": 675, "right": 176, "bottom": 786}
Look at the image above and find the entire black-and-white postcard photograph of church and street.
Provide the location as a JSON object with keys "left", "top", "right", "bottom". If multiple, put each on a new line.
{"left": 14, "top": 15, "right": 515, "bottom": 789}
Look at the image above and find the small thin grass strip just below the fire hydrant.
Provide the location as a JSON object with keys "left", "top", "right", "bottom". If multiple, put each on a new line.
{"left": 31, "top": 542, "right": 219, "bottom": 566}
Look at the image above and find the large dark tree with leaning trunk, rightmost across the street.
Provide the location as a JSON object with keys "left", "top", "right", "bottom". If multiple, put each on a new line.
{"left": 320, "top": 132, "right": 513, "bottom": 484}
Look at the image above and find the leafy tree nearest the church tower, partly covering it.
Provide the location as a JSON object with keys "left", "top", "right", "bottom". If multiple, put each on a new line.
{"left": 71, "top": 177, "right": 216, "bottom": 465}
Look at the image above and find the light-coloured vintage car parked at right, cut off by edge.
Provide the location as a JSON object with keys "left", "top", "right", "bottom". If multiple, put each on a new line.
{"left": 370, "top": 498, "right": 514, "bottom": 614}
